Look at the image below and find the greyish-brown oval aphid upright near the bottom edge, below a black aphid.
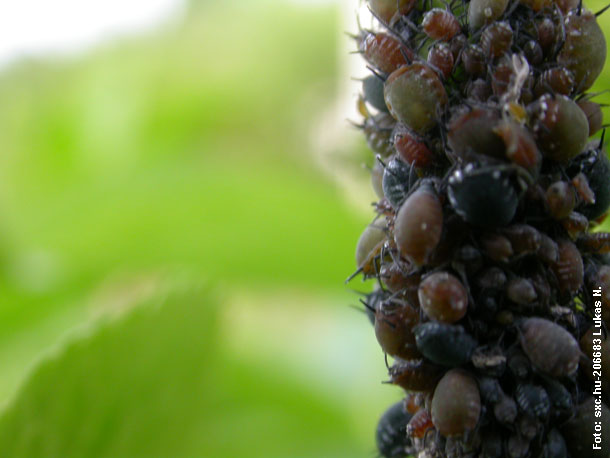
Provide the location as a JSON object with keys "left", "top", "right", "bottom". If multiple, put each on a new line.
{"left": 431, "top": 369, "right": 481, "bottom": 437}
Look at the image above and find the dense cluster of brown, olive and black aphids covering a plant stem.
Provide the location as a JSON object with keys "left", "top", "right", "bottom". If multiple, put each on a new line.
{"left": 354, "top": 0, "right": 610, "bottom": 458}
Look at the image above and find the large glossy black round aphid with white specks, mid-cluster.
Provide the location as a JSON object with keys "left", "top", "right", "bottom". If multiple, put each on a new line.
{"left": 448, "top": 165, "right": 519, "bottom": 227}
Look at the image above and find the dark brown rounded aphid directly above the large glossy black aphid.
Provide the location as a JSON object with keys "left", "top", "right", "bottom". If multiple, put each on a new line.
{"left": 447, "top": 108, "right": 504, "bottom": 160}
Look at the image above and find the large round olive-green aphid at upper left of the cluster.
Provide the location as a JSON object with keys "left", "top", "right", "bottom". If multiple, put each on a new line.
{"left": 384, "top": 62, "right": 446, "bottom": 134}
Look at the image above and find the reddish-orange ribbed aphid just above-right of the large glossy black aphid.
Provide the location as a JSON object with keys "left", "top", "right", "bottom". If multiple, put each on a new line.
{"left": 494, "top": 120, "right": 542, "bottom": 173}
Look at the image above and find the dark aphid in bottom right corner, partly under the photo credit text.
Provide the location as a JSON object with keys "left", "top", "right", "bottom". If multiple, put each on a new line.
{"left": 560, "top": 397, "right": 610, "bottom": 458}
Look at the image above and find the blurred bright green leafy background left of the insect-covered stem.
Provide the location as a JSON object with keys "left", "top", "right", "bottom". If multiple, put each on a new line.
{"left": 0, "top": 0, "right": 610, "bottom": 457}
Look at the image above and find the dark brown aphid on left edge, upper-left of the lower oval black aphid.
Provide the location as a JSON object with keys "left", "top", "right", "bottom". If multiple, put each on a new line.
{"left": 375, "top": 303, "right": 421, "bottom": 359}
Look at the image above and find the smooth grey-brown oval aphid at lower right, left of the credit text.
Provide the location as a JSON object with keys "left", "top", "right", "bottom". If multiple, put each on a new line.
{"left": 520, "top": 318, "right": 580, "bottom": 377}
